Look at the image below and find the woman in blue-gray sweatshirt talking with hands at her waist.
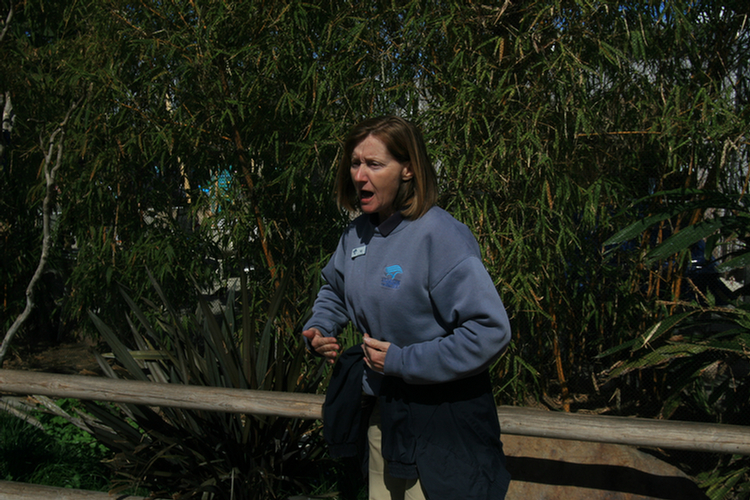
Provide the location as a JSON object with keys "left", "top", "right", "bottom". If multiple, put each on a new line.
{"left": 303, "top": 116, "right": 510, "bottom": 500}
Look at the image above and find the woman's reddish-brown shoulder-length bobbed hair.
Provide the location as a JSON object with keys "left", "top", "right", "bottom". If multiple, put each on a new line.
{"left": 336, "top": 116, "right": 438, "bottom": 219}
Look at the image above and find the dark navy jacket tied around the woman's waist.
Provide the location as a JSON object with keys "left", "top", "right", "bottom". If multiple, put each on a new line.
{"left": 323, "top": 346, "right": 510, "bottom": 500}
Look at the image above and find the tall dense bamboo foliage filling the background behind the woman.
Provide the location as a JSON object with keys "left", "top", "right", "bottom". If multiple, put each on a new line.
{"left": 0, "top": 0, "right": 748, "bottom": 418}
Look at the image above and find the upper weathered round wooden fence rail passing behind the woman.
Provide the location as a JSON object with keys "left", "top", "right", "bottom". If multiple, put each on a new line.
{"left": 0, "top": 369, "right": 750, "bottom": 455}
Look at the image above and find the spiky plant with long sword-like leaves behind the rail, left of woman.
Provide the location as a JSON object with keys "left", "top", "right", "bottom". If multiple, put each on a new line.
{"left": 91, "top": 273, "right": 324, "bottom": 499}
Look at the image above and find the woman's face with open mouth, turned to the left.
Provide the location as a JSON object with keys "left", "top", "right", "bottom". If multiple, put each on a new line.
{"left": 349, "top": 135, "right": 414, "bottom": 222}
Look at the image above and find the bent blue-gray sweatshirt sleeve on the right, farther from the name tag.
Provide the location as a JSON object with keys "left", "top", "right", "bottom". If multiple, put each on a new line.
{"left": 385, "top": 256, "right": 510, "bottom": 384}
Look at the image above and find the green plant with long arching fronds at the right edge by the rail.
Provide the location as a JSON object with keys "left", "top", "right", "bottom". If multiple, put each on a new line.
{"left": 601, "top": 189, "right": 750, "bottom": 500}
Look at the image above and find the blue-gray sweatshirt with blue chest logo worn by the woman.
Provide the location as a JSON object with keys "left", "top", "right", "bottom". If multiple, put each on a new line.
{"left": 305, "top": 207, "right": 510, "bottom": 388}
